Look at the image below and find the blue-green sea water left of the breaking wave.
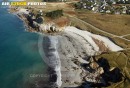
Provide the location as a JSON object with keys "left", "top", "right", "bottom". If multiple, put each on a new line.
{"left": 0, "top": 8, "right": 46, "bottom": 88}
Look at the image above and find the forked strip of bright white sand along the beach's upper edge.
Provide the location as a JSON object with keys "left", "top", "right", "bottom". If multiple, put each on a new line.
{"left": 65, "top": 27, "right": 123, "bottom": 52}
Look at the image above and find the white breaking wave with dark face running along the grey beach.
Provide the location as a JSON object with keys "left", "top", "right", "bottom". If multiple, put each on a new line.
{"left": 38, "top": 35, "right": 62, "bottom": 87}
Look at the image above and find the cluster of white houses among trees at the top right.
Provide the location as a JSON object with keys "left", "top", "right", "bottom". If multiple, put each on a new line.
{"left": 77, "top": 0, "right": 130, "bottom": 14}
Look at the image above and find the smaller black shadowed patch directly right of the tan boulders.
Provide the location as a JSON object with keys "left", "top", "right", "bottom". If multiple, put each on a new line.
{"left": 97, "top": 57, "right": 110, "bottom": 72}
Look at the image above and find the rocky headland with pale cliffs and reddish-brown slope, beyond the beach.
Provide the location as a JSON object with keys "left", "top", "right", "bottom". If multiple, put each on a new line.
{"left": 10, "top": 8, "right": 70, "bottom": 35}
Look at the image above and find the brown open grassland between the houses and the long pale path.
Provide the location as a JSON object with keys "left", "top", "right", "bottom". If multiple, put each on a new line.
{"left": 77, "top": 10, "right": 130, "bottom": 36}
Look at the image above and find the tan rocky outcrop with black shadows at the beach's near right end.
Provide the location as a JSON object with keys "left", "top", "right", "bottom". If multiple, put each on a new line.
{"left": 82, "top": 58, "right": 123, "bottom": 88}
